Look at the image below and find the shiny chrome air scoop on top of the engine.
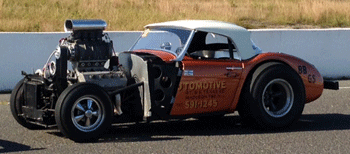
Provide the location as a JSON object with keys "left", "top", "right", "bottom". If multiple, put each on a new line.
{"left": 64, "top": 19, "right": 107, "bottom": 32}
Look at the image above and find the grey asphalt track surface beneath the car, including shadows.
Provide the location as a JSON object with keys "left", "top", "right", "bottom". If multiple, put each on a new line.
{"left": 0, "top": 81, "right": 350, "bottom": 153}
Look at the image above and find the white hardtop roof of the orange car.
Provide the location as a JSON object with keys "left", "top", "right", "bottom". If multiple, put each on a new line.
{"left": 145, "top": 20, "right": 257, "bottom": 60}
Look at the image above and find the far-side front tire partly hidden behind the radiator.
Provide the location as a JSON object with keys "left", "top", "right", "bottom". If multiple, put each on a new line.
{"left": 10, "top": 79, "right": 44, "bottom": 130}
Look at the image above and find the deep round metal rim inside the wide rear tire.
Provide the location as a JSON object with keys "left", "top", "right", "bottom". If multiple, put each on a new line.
{"left": 262, "top": 79, "right": 294, "bottom": 118}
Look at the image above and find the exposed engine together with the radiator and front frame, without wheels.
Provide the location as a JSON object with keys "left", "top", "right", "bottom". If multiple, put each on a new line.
{"left": 18, "top": 20, "right": 127, "bottom": 126}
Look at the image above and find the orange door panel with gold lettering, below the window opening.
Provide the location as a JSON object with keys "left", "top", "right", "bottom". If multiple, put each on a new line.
{"left": 171, "top": 58, "right": 243, "bottom": 115}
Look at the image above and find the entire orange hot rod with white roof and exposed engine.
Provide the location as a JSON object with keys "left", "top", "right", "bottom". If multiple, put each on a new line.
{"left": 10, "top": 20, "right": 336, "bottom": 141}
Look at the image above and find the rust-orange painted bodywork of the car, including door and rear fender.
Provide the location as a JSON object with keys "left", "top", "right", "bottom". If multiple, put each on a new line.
{"left": 134, "top": 50, "right": 323, "bottom": 115}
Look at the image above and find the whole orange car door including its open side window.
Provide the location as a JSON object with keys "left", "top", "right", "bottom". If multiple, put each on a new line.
{"left": 170, "top": 31, "right": 243, "bottom": 115}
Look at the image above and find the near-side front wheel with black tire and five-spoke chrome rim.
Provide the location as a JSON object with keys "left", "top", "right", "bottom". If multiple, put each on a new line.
{"left": 55, "top": 83, "right": 113, "bottom": 142}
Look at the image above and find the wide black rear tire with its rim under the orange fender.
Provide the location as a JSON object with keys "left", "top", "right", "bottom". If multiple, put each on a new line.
{"left": 238, "top": 64, "right": 305, "bottom": 130}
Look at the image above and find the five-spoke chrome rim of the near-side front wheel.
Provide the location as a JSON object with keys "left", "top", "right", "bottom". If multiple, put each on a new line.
{"left": 71, "top": 96, "right": 105, "bottom": 132}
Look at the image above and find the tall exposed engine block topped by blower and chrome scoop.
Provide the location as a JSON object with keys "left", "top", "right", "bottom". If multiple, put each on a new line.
{"left": 44, "top": 20, "right": 126, "bottom": 89}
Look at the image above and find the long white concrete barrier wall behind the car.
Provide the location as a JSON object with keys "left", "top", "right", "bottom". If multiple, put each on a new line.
{"left": 0, "top": 29, "right": 350, "bottom": 92}
